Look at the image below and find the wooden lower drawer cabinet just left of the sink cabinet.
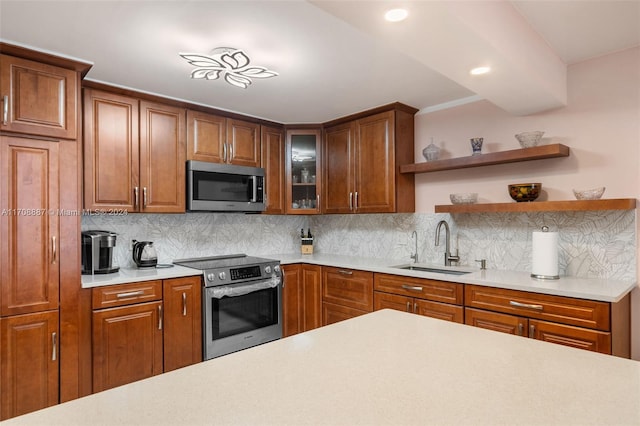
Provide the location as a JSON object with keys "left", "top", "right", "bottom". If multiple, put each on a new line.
{"left": 322, "top": 266, "right": 373, "bottom": 325}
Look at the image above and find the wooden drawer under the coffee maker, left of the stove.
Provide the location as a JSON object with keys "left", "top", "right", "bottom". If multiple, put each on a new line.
{"left": 92, "top": 280, "right": 162, "bottom": 309}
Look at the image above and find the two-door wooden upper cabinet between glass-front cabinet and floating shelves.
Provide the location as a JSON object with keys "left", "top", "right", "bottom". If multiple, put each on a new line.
{"left": 323, "top": 104, "right": 416, "bottom": 213}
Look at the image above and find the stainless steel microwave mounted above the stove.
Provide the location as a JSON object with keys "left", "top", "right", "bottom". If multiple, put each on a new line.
{"left": 186, "top": 160, "right": 265, "bottom": 212}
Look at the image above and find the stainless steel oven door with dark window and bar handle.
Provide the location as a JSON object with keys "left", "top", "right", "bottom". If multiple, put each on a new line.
{"left": 202, "top": 277, "right": 282, "bottom": 359}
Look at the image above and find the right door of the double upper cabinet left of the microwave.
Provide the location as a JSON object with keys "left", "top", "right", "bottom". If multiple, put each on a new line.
{"left": 140, "top": 102, "right": 186, "bottom": 213}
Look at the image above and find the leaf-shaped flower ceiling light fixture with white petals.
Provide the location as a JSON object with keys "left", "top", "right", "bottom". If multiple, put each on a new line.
{"left": 179, "top": 47, "right": 278, "bottom": 89}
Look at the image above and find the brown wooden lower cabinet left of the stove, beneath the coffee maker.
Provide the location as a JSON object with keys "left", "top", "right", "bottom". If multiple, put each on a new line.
{"left": 92, "top": 277, "right": 202, "bottom": 392}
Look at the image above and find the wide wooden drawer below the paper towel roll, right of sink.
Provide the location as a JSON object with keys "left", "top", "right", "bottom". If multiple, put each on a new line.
{"left": 465, "top": 285, "right": 610, "bottom": 331}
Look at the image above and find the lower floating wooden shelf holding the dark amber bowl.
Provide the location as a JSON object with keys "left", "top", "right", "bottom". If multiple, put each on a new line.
{"left": 435, "top": 198, "right": 636, "bottom": 213}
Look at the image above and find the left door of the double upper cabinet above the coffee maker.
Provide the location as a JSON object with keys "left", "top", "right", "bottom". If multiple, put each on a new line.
{"left": 84, "top": 89, "right": 140, "bottom": 212}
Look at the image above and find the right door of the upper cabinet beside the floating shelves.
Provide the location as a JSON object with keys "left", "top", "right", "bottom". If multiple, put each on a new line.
{"left": 354, "top": 111, "right": 396, "bottom": 213}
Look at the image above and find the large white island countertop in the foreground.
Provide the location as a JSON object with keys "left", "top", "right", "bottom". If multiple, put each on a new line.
{"left": 3, "top": 310, "right": 640, "bottom": 426}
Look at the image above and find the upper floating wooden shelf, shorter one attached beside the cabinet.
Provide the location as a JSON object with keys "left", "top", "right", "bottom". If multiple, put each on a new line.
{"left": 400, "top": 143, "right": 569, "bottom": 173}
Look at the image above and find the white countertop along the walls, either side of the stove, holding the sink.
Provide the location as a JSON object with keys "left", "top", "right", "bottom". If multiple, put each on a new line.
{"left": 82, "top": 253, "right": 636, "bottom": 302}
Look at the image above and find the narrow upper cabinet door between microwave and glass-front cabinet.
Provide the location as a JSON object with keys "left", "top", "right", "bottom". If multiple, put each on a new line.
{"left": 260, "top": 126, "right": 285, "bottom": 214}
